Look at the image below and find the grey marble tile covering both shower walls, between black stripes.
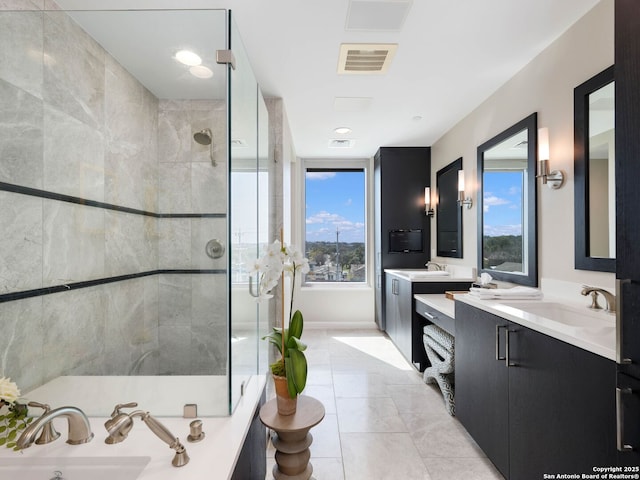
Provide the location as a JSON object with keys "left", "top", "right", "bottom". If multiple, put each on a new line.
{"left": 0, "top": 6, "right": 227, "bottom": 390}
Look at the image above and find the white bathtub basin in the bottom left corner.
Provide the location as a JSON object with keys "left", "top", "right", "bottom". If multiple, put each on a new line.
{"left": 0, "top": 456, "right": 151, "bottom": 480}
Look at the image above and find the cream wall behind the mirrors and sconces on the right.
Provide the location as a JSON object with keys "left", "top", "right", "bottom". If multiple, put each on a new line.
{"left": 431, "top": 0, "right": 614, "bottom": 288}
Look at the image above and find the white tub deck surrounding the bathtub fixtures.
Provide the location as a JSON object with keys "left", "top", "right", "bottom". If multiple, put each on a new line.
{"left": 0, "top": 375, "right": 266, "bottom": 480}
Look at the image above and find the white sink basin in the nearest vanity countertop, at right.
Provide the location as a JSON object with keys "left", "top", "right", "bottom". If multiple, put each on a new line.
{"left": 500, "top": 300, "right": 615, "bottom": 333}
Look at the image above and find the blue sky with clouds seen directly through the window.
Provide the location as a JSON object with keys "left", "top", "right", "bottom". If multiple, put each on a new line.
{"left": 305, "top": 171, "right": 366, "bottom": 243}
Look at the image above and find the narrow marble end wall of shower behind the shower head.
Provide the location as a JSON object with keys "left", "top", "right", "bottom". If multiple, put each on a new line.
{"left": 158, "top": 100, "right": 228, "bottom": 375}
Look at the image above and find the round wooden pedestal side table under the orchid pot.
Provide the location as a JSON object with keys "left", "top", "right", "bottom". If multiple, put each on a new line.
{"left": 260, "top": 395, "right": 324, "bottom": 480}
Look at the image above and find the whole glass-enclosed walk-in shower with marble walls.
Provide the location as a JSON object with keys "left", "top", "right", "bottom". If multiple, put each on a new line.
{"left": 0, "top": 0, "right": 273, "bottom": 416}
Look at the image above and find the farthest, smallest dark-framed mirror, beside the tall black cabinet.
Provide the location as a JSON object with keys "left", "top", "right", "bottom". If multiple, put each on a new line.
{"left": 436, "top": 157, "right": 462, "bottom": 258}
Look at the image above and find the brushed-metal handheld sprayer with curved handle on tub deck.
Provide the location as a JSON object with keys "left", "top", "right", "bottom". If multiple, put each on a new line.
{"left": 104, "top": 402, "right": 189, "bottom": 467}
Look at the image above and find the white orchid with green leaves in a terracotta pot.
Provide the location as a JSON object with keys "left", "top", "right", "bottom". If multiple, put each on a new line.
{"left": 252, "top": 240, "right": 309, "bottom": 415}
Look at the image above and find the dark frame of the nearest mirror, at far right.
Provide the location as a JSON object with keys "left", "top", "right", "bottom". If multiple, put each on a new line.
{"left": 573, "top": 65, "right": 616, "bottom": 272}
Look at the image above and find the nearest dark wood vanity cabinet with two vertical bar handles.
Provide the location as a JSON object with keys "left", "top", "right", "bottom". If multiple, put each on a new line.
{"left": 455, "top": 302, "right": 616, "bottom": 480}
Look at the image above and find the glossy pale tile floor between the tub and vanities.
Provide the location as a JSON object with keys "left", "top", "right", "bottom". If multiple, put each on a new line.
{"left": 267, "top": 328, "right": 503, "bottom": 480}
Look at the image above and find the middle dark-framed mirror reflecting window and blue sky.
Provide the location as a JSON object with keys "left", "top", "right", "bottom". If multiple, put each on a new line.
{"left": 477, "top": 113, "right": 538, "bottom": 287}
